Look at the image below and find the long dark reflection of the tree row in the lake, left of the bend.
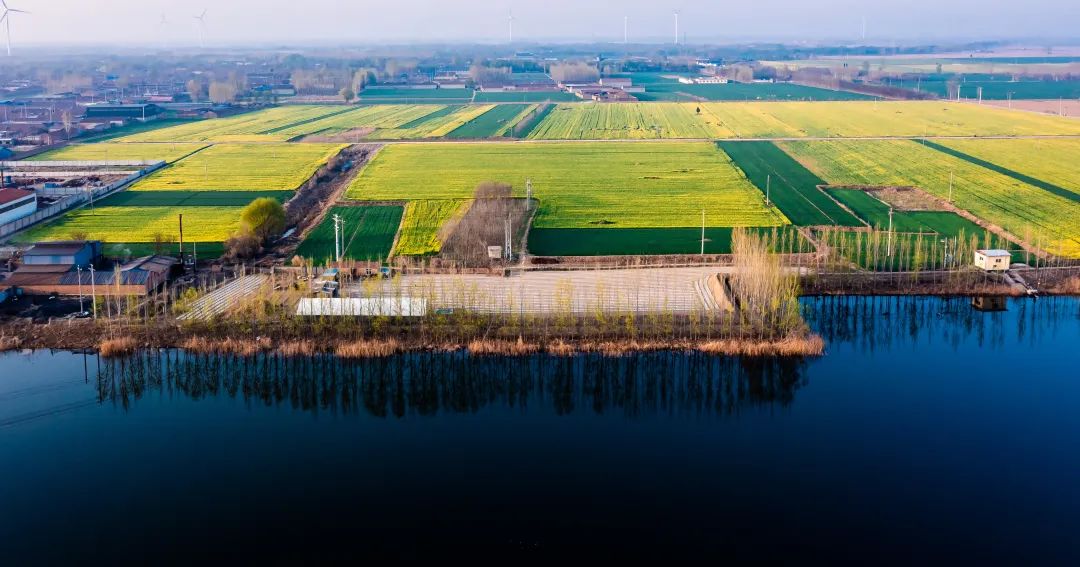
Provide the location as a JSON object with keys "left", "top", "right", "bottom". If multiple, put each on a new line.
{"left": 97, "top": 350, "right": 806, "bottom": 418}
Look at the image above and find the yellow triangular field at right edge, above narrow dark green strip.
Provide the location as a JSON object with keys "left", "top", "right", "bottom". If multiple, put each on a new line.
{"left": 933, "top": 138, "right": 1080, "bottom": 199}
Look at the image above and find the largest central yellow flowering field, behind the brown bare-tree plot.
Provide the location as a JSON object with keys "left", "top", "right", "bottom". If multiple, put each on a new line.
{"left": 347, "top": 143, "right": 788, "bottom": 228}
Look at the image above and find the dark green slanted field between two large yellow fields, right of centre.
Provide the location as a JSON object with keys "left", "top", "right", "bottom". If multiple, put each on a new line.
{"left": 718, "top": 141, "right": 862, "bottom": 227}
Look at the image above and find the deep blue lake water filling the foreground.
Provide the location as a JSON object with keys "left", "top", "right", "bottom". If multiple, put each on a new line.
{"left": 0, "top": 298, "right": 1080, "bottom": 565}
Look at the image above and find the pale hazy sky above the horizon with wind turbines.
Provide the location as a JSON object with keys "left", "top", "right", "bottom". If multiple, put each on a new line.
{"left": 6, "top": 0, "right": 1080, "bottom": 45}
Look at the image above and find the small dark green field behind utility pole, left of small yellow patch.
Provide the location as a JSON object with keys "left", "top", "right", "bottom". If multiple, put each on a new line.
{"left": 296, "top": 205, "right": 404, "bottom": 262}
